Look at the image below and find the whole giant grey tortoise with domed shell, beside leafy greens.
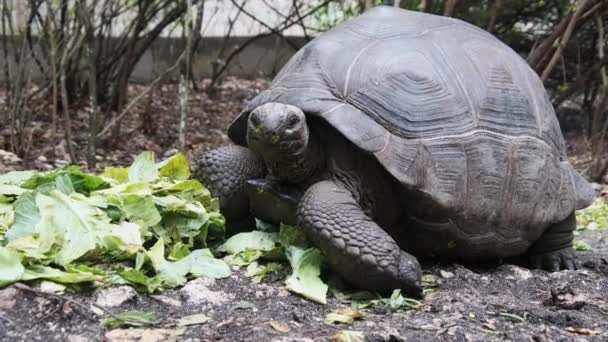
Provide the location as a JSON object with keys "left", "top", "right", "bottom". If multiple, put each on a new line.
{"left": 195, "top": 7, "right": 594, "bottom": 295}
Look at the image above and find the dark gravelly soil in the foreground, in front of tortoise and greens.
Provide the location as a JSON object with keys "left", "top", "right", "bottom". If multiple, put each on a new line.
{"left": 0, "top": 228, "right": 608, "bottom": 342}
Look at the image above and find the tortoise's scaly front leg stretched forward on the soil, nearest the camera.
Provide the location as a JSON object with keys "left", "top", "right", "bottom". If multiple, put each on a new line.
{"left": 297, "top": 181, "right": 422, "bottom": 296}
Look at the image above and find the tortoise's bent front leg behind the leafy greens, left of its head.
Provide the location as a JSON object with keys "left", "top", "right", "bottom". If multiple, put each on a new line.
{"left": 193, "top": 145, "right": 266, "bottom": 231}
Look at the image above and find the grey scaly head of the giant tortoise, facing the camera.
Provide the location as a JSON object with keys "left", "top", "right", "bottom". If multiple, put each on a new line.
{"left": 247, "top": 103, "right": 309, "bottom": 163}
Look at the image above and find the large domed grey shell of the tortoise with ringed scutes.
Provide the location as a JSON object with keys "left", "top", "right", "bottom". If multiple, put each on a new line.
{"left": 229, "top": 7, "right": 594, "bottom": 254}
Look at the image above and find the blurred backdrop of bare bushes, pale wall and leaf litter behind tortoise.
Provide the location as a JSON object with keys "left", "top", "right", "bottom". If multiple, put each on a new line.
{"left": 0, "top": 0, "right": 608, "bottom": 187}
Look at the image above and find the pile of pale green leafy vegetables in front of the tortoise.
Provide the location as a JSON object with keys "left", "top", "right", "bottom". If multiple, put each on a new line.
{"left": 0, "top": 152, "right": 327, "bottom": 303}
